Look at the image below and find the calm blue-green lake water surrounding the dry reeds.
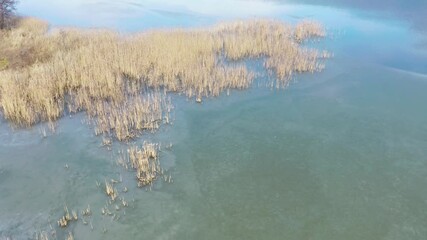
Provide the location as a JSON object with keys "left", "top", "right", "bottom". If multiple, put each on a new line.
{"left": 0, "top": 0, "right": 427, "bottom": 240}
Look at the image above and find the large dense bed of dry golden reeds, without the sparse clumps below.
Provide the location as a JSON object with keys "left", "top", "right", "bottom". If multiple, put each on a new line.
{"left": 0, "top": 19, "right": 328, "bottom": 141}
